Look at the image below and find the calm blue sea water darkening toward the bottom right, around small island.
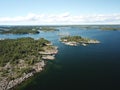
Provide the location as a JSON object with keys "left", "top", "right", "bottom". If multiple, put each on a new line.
{"left": 0, "top": 28, "right": 120, "bottom": 90}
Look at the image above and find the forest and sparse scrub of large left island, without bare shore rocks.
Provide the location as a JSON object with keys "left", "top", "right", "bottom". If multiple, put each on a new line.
{"left": 0, "top": 37, "right": 57, "bottom": 80}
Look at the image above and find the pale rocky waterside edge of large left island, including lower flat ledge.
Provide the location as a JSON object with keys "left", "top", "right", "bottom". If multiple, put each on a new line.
{"left": 0, "top": 47, "right": 58, "bottom": 90}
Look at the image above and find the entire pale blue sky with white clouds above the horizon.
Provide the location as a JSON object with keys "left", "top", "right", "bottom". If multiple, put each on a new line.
{"left": 0, "top": 0, "right": 120, "bottom": 25}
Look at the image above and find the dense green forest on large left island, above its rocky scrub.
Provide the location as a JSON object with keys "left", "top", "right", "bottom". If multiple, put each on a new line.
{"left": 0, "top": 38, "right": 50, "bottom": 66}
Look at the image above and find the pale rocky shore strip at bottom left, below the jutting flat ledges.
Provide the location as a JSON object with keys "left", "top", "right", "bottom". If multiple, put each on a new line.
{"left": 0, "top": 60, "right": 45, "bottom": 90}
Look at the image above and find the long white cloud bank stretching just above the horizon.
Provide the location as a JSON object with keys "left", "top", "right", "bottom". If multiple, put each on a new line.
{"left": 0, "top": 12, "right": 120, "bottom": 25}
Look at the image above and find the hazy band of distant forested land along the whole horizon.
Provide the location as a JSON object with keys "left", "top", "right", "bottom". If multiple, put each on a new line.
{"left": 0, "top": 25, "right": 120, "bottom": 34}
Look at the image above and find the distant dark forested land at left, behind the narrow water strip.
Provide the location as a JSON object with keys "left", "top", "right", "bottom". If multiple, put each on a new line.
{"left": 0, "top": 26, "right": 59, "bottom": 34}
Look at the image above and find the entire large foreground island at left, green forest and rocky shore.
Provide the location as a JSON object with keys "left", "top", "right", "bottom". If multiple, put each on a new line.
{"left": 0, "top": 37, "right": 58, "bottom": 90}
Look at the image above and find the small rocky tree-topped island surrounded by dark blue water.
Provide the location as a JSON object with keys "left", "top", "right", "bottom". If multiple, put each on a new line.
{"left": 60, "top": 36, "right": 100, "bottom": 46}
